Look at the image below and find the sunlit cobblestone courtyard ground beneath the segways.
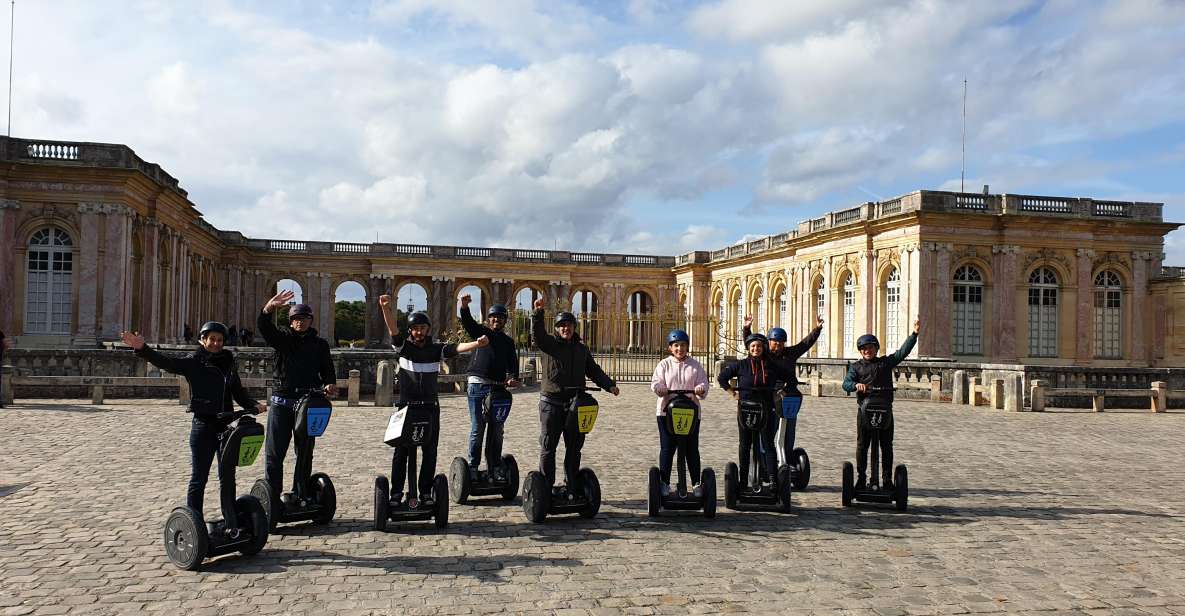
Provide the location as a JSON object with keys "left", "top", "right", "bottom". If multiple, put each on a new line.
{"left": 0, "top": 385, "right": 1185, "bottom": 616}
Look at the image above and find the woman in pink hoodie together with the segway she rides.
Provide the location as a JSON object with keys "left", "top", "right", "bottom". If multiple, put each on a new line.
{"left": 647, "top": 329, "right": 716, "bottom": 518}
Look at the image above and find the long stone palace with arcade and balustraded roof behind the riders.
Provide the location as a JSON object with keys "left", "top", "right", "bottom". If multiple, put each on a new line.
{"left": 0, "top": 137, "right": 1185, "bottom": 367}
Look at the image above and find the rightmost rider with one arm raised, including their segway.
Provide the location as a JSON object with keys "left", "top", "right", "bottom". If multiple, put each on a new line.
{"left": 843, "top": 321, "right": 921, "bottom": 511}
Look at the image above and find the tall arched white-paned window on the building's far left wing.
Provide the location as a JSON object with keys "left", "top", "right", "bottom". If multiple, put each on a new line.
{"left": 25, "top": 226, "right": 73, "bottom": 334}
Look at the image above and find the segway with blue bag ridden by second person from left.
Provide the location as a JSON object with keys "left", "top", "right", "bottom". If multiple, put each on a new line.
{"left": 251, "top": 389, "right": 338, "bottom": 531}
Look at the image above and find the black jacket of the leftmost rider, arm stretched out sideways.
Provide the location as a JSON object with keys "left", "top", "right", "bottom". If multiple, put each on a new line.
{"left": 135, "top": 345, "right": 256, "bottom": 419}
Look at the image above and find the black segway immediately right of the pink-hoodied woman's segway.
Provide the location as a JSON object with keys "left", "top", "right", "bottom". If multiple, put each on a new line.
{"left": 724, "top": 387, "right": 793, "bottom": 513}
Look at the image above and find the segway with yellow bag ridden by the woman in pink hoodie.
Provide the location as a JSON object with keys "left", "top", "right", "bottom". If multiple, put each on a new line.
{"left": 646, "top": 390, "right": 716, "bottom": 518}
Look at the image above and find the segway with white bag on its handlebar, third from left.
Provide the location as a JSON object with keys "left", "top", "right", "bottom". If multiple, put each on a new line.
{"left": 374, "top": 400, "right": 448, "bottom": 531}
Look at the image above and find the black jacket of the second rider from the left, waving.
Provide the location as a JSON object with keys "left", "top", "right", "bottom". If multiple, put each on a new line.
{"left": 256, "top": 310, "right": 338, "bottom": 396}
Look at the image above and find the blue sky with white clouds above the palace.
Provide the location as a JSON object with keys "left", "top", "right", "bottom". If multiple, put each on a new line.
{"left": 9, "top": 0, "right": 1185, "bottom": 278}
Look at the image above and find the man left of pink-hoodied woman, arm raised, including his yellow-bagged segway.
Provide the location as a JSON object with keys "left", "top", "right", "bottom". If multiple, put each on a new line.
{"left": 523, "top": 299, "right": 621, "bottom": 522}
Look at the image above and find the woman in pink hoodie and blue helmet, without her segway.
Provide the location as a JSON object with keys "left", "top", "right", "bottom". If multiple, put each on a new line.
{"left": 651, "top": 329, "right": 707, "bottom": 496}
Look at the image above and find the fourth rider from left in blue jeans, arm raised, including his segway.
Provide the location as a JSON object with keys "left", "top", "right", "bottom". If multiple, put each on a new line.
{"left": 448, "top": 294, "right": 519, "bottom": 505}
